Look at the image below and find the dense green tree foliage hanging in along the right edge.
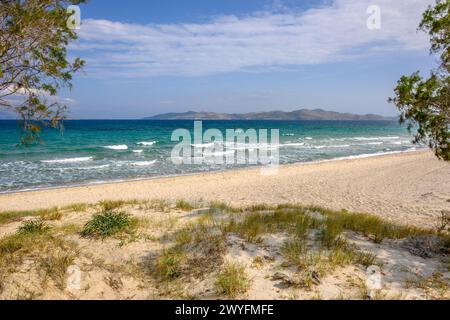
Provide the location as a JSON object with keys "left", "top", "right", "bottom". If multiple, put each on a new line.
{"left": 389, "top": 0, "right": 450, "bottom": 161}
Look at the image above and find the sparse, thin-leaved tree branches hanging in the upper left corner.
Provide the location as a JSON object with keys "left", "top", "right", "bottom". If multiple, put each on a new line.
{"left": 0, "top": 0, "right": 85, "bottom": 144}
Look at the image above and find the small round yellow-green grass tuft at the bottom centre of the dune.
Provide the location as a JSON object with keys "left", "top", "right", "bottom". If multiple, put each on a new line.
{"left": 215, "top": 263, "right": 250, "bottom": 299}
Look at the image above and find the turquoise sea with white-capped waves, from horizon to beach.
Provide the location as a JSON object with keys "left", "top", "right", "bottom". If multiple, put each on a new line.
{"left": 0, "top": 120, "right": 414, "bottom": 192}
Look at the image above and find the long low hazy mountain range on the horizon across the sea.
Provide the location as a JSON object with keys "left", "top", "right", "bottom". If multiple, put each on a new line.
{"left": 144, "top": 109, "right": 396, "bottom": 121}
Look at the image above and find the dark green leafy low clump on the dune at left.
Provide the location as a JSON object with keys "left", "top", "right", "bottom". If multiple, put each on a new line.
{"left": 81, "top": 211, "right": 135, "bottom": 238}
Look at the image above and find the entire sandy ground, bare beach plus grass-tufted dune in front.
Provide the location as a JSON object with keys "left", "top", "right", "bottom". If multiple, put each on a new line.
{"left": 0, "top": 152, "right": 450, "bottom": 300}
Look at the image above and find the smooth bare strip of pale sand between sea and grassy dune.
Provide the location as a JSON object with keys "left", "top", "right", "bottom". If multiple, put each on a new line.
{"left": 0, "top": 151, "right": 450, "bottom": 226}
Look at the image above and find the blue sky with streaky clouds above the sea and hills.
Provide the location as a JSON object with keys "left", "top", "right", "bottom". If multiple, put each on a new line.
{"left": 54, "top": 0, "right": 436, "bottom": 119}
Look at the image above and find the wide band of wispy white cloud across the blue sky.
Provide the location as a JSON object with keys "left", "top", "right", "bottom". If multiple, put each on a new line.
{"left": 72, "top": 0, "right": 433, "bottom": 77}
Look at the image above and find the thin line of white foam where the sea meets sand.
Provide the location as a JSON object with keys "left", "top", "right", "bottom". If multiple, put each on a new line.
{"left": 0, "top": 148, "right": 427, "bottom": 196}
